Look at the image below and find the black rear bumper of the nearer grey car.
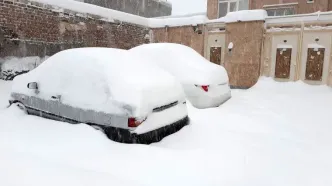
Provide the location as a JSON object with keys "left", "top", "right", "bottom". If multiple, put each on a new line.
{"left": 105, "top": 116, "right": 189, "bottom": 144}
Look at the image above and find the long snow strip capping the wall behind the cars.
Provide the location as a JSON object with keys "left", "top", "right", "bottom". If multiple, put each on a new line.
{"left": 30, "top": 0, "right": 267, "bottom": 28}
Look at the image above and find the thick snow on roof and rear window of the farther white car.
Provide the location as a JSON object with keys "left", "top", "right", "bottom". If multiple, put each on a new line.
{"left": 129, "top": 43, "right": 228, "bottom": 85}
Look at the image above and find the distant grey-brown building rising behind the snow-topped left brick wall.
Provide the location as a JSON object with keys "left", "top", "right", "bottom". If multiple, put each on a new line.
{"left": 77, "top": 0, "right": 172, "bottom": 17}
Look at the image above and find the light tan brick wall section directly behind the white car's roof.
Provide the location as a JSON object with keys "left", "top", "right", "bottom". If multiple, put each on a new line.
{"left": 152, "top": 25, "right": 204, "bottom": 55}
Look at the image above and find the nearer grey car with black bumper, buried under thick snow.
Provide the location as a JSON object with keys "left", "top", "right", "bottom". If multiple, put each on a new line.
{"left": 9, "top": 48, "right": 189, "bottom": 144}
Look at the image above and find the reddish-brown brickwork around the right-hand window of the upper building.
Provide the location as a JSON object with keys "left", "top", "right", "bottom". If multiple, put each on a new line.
{"left": 250, "top": 0, "right": 329, "bottom": 14}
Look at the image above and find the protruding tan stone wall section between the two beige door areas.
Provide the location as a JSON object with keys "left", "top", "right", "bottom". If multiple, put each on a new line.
{"left": 224, "top": 21, "right": 264, "bottom": 88}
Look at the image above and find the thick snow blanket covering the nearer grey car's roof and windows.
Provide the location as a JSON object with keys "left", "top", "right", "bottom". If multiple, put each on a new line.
{"left": 13, "top": 48, "right": 184, "bottom": 117}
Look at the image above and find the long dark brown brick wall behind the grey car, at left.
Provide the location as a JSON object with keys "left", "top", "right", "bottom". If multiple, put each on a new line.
{"left": 0, "top": 0, "right": 149, "bottom": 57}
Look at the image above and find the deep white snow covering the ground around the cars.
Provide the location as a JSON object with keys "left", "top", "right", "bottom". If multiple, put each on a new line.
{"left": 0, "top": 78, "right": 332, "bottom": 186}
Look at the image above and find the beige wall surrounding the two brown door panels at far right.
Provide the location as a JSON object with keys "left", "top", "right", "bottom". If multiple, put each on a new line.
{"left": 261, "top": 27, "right": 332, "bottom": 86}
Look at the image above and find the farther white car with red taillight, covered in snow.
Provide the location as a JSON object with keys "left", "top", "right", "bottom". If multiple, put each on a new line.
{"left": 129, "top": 43, "right": 231, "bottom": 108}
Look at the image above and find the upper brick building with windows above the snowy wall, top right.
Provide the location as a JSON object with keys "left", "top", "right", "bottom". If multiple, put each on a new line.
{"left": 207, "top": 0, "right": 332, "bottom": 19}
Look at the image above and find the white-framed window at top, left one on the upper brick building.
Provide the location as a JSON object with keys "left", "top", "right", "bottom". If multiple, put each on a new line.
{"left": 219, "top": 0, "right": 249, "bottom": 17}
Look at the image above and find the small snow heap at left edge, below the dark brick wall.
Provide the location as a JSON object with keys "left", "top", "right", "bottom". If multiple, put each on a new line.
{"left": 0, "top": 56, "right": 48, "bottom": 80}
